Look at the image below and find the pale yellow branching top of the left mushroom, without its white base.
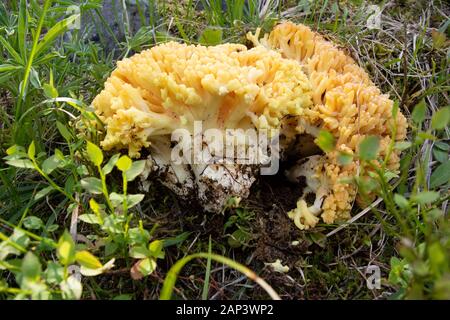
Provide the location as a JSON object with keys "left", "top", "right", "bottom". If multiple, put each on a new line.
{"left": 93, "top": 42, "right": 312, "bottom": 157}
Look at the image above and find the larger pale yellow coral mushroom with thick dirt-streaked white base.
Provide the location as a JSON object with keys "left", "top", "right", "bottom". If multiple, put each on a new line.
{"left": 92, "top": 42, "right": 312, "bottom": 211}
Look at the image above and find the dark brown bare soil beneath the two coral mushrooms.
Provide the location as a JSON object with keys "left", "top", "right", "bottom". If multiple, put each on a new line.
{"left": 142, "top": 156, "right": 328, "bottom": 299}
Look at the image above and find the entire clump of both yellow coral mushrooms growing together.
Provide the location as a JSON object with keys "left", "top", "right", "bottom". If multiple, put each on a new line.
{"left": 92, "top": 22, "right": 406, "bottom": 229}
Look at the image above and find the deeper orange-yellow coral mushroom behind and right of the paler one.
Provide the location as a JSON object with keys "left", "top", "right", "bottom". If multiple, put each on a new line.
{"left": 249, "top": 22, "right": 407, "bottom": 223}
